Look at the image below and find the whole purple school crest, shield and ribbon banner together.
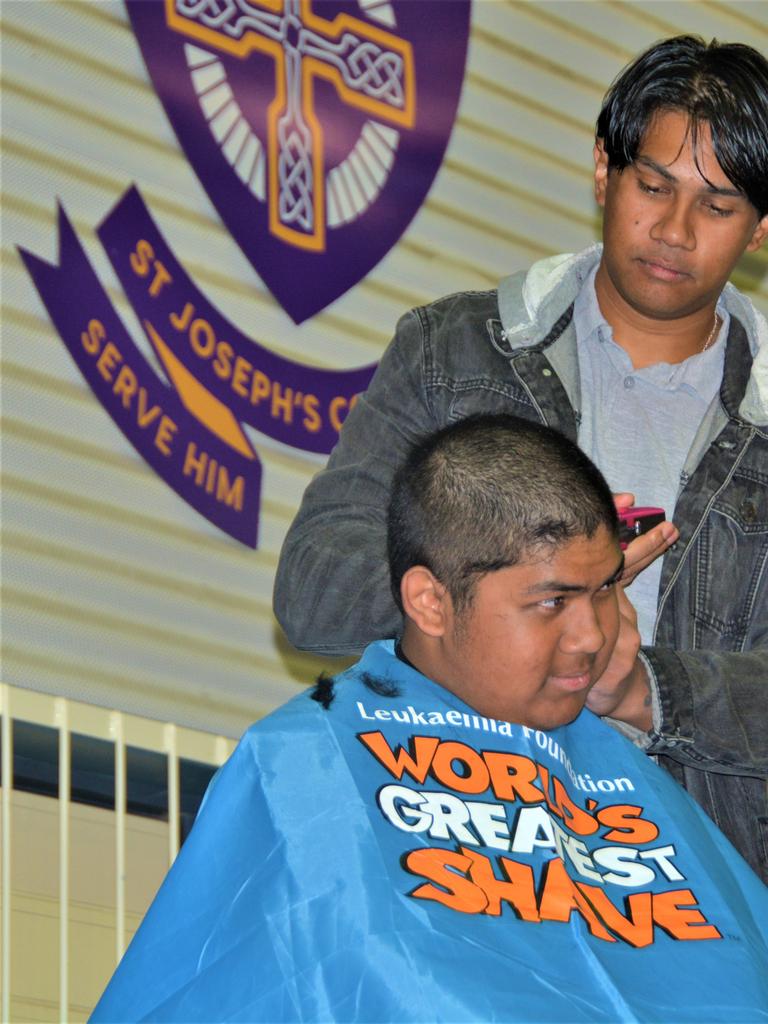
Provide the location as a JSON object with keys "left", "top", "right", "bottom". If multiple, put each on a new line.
{"left": 22, "top": 0, "right": 469, "bottom": 547}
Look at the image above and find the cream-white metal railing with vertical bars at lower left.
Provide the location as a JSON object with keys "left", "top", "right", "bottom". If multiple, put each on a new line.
{"left": 0, "top": 684, "right": 234, "bottom": 1024}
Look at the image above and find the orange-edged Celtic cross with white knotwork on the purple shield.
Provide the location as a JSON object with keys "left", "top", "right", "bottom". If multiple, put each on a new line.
{"left": 166, "top": 0, "right": 416, "bottom": 251}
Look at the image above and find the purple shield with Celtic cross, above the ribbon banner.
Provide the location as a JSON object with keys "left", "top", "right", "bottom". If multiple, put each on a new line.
{"left": 127, "top": 0, "right": 470, "bottom": 324}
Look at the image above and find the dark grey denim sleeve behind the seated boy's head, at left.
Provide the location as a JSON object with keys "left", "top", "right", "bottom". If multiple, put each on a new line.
{"left": 273, "top": 310, "right": 437, "bottom": 655}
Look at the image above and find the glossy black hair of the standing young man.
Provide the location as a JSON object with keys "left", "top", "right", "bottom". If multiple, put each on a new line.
{"left": 596, "top": 36, "right": 768, "bottom": 218}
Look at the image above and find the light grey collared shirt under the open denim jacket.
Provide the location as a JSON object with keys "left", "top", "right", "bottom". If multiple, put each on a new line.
{"left": 573, "top": 268, "right": 730, "bottom": 645}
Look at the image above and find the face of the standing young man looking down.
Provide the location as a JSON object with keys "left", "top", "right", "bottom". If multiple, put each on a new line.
{"left": 595, "top": 111, "right": 768, "bottom": 321}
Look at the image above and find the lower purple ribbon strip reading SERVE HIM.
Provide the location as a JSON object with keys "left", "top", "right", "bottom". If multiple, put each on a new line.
{"left": 19, "top": 202, "right": 261, "bottom": 548}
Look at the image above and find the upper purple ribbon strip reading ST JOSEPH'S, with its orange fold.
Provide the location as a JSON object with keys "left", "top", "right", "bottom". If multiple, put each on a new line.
{"left": 98, "top": 187, "right": 376, "bottom": 454}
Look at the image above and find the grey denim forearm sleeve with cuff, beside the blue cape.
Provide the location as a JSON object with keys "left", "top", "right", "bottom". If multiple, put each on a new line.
{"left": 642, "top": 645, "right": 768, "bottom": 778}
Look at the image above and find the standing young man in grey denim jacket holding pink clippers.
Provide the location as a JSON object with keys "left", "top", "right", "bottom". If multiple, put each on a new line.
{"left": 274, "top": 36, "right": 768, "bottom": 880}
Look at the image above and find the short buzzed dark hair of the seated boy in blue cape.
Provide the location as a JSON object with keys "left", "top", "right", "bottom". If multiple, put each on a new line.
{"left": 387, "top": 415, "right": 618, "bottom": 611}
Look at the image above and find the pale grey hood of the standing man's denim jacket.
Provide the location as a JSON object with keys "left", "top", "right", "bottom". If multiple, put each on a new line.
{"left": 499, "top": 243, "right": 768, "bottom": 426}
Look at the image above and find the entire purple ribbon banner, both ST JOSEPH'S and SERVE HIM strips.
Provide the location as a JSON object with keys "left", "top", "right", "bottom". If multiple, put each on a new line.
{"left": 20, "top": 186, "right": 382, "bottom": 548}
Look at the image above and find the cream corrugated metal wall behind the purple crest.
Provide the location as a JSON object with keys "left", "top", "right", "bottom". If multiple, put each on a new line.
{"left": 0, "top": 0, "right": 768, "bottom": 734}
